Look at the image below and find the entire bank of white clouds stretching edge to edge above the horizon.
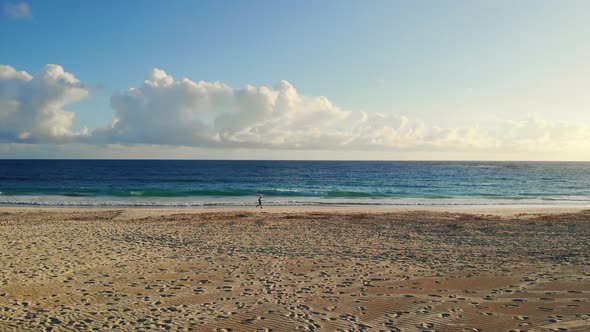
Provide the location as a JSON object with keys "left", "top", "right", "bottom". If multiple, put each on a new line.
{"left": 0, "top": 65, "right": 590, "bottom": 158}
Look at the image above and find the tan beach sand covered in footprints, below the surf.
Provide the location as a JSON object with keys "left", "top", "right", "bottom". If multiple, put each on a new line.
{"left": 0, "top": 207, "right": 590, "bottom": 331}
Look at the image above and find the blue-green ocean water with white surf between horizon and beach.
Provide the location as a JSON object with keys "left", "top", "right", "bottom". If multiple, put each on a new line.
{"left": 0, "top": 160, "right": 590, "bottom": 206}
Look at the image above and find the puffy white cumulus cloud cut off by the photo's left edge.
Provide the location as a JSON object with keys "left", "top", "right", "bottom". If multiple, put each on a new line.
{"left": 0, "top": 65, "right": 88, "bottom": 142}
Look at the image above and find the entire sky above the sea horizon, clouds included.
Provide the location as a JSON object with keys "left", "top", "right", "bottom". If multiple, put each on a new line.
{"left": 0, "top": 0, "right": 590, "bottom": 161}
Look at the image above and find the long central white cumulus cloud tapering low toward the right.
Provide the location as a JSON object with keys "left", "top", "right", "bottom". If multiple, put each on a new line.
{"left": 93, "top": 69, "right": 500, "bottom": 149}
